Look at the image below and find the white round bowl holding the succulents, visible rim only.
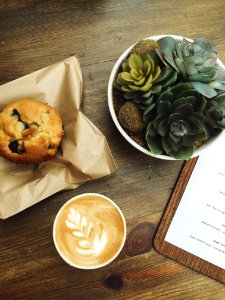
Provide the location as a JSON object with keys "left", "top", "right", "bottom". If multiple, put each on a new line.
{"left": 108, "top": 35, "right": 225, "bottom": 160}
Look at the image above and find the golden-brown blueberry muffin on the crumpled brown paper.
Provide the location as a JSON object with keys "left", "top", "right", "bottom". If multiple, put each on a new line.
{"left": 0, "top": 99, "right": 63, "bottom": 164}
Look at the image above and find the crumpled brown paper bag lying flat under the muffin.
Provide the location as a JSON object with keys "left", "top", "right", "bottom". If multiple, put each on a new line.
{"left": 0, "top": 56, "right": 115, "bottom": 219}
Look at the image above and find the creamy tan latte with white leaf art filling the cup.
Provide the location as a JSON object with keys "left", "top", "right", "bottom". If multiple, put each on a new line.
{"left": 53, "top": 194, "right": 126, "bottom": 269}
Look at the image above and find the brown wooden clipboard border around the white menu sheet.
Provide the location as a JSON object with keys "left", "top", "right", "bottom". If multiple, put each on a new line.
{"left": 154, "top": 158, "right": 225, "bottom": 283}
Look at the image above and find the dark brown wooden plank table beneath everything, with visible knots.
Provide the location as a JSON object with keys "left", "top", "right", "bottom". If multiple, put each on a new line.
{"left": 0, "top": 0, "right": 225, "bottom": 300}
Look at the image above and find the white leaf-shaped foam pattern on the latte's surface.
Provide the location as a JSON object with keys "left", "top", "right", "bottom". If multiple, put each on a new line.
{"left": 66, "top": 208, "right": 108, "bottom": 257}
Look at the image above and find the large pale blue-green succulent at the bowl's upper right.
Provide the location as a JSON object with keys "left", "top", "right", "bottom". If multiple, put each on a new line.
{"left": 156, "top": 36, "right": 225, "bottom": 98}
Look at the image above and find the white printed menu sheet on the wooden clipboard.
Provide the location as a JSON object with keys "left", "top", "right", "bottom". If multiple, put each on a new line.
{"left": 165, "top": 138, "right": 225, "bottom": 270}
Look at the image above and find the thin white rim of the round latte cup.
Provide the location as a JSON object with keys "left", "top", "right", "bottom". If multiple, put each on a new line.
{"left": 52, "top": 193, "right": 126, "bottom": 270}
